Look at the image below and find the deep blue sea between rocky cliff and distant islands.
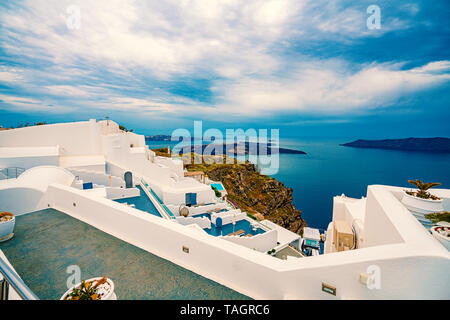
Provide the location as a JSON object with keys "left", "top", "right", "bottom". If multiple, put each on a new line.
{"left": 147, "top": 138, "right": 450, "bottom": 229}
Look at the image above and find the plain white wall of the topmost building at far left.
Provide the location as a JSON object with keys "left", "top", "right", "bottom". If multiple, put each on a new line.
{"left": 0, "top": 120, "right": 101, "bottom": 156}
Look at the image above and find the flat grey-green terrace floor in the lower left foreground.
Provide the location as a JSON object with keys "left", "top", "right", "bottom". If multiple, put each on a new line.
{"left": 0, "top": 209, "right": 250, "bottom": 300}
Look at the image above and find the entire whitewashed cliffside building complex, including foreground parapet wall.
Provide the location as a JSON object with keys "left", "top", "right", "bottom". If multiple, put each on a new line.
{"left": 0, "top": 120, "right": 450, "bottom": 299}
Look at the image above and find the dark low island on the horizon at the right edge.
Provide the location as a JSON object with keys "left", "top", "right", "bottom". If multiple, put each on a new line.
{"left": 341, "top": 138, "right": 450, "bottom": 153}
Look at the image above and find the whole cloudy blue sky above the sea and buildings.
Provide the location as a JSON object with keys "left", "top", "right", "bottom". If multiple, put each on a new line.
{"left": 0, "top": 0, "right": 450, "bottom": 138}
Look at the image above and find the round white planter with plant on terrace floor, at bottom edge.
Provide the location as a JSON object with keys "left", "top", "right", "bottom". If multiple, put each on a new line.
{"left": 61, "top": 277, "right": 117, "bottom": 300}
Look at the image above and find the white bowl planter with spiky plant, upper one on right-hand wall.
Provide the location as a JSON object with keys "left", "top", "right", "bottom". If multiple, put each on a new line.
{"left": 402, "top": 180, "right": 444, "bottom": 219}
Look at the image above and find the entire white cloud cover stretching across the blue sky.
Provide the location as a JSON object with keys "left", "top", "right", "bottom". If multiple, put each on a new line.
{"left": 0, "top": 0, "right": 450, "bottom": 120}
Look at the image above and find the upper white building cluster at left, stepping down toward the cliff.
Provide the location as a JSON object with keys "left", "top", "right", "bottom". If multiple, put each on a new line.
{"left": 0, "top": 120, "right": 214, "bottom": 205}
